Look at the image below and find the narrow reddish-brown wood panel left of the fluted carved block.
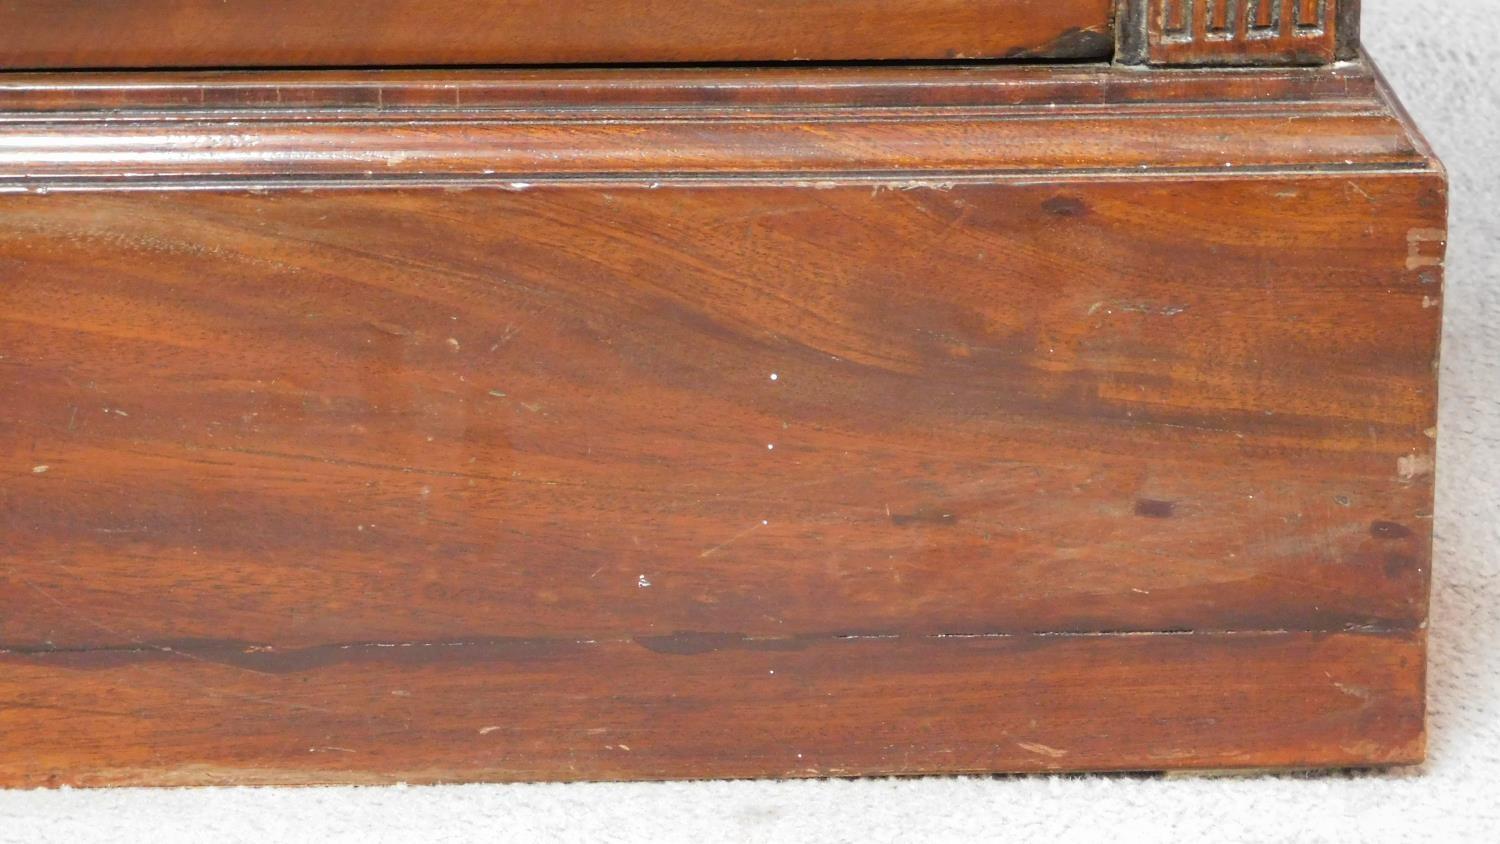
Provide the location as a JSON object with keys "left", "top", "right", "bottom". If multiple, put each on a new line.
{"left": 0, "top": 0, "right": 1115, "bottom": 69}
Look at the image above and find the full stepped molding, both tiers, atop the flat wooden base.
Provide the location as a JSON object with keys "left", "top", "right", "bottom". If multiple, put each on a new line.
{"left": 0, "top": 67, "right": 1427, "bottom": 189}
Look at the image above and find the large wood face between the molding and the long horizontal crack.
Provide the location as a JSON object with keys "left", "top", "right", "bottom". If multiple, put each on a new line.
{"left": 0, "top": 175, "right": 1442, "bottom": 646}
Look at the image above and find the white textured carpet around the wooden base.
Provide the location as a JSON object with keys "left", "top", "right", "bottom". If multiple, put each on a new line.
{"left": 0, "top": 0, "right": 1500, "bottom": 844}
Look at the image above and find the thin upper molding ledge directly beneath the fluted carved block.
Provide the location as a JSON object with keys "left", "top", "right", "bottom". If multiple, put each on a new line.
{"left": 0, "top": 64, "right": 1377, "bottom": 112}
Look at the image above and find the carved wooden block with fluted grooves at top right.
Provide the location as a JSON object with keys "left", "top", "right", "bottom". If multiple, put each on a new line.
{"left": 1116, "top": 0, "right": 1359, "bottom": 66}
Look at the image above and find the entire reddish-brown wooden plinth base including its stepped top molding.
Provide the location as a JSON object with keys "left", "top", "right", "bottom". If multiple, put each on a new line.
{"left": 0, "top": 63, "right": 1446, "bottom": 786}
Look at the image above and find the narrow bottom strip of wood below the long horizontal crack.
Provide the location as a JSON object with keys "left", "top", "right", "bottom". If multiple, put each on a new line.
{"left": 0, "top": 631, "right": 1425, "bottom": 786}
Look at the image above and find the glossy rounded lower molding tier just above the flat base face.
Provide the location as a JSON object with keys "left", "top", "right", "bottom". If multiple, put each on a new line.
{"left": 0, "top": 112, "right": 1422, "bottom": 181}
